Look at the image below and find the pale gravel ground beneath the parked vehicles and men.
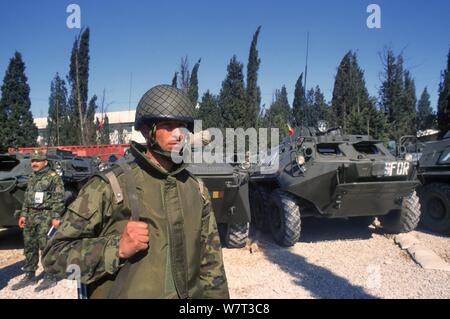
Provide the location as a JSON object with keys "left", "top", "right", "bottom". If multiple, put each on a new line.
{"left": 0, "top": 219, "right": 450, "bottom": 299}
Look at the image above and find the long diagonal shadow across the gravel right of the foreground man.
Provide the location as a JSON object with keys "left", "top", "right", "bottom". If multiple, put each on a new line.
{"left": 261, "top": 239, "right": 378, "bottom": 299}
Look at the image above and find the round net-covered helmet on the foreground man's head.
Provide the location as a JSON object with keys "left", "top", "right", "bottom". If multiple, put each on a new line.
{"left": 134, "top": 85, "right": 194, "bottom": 132}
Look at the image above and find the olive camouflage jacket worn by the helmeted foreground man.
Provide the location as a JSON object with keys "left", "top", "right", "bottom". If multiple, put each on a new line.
{"left": 43, "top": 144, "right": 229, "bottom": 298}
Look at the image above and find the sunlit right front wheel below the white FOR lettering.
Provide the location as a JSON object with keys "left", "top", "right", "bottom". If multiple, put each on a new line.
{"left": 378, "top": 191, "right": 420, "bottom": 234}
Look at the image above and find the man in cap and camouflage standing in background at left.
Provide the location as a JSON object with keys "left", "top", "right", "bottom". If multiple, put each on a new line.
{"left": 12, "top": 150, "right": 65, "bottom": 291}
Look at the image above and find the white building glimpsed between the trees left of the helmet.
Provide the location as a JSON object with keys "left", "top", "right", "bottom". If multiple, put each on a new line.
{"left": 34, "top": 111, "right": 145, "bottom": 144}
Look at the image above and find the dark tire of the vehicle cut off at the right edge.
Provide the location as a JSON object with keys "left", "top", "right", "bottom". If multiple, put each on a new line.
{"left": 420, "top": 183, "right": 450, "bottom": 234}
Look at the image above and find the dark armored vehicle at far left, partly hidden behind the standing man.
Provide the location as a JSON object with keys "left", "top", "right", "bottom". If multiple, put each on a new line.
{"left": 0, "top": 149, "right": 101, "bottom": 227}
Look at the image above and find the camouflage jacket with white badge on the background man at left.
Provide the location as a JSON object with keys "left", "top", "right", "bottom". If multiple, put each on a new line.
{"left": 20, "top": 167, "right": 65, "bottom": 218}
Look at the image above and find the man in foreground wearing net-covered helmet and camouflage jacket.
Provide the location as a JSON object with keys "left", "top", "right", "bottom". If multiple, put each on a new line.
{"left": 44, "top": 85, "right": 229, "bottom": 298}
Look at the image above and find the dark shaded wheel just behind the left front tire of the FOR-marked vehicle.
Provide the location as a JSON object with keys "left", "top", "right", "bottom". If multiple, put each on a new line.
{"left": 250, "top": 186, "right": 270, "bottom": 232}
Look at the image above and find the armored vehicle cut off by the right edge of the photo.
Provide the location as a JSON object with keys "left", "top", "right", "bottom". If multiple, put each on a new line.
{"left": 418, "top": 131, "right": 450, "bottom": 234}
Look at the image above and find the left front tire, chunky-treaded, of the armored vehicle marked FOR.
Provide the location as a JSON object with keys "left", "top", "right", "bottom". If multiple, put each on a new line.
{"left": 269, "top": 189, "right": 301, "bottom": 247}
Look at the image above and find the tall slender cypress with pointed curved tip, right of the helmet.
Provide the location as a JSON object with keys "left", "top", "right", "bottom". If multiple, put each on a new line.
{"left": 246, "top": 26, "right": 261, "bottom": 127}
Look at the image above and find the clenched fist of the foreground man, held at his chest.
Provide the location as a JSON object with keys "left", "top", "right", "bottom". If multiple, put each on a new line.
{"left": 119, "top": 222, "right": 150, "bottom": 259}
